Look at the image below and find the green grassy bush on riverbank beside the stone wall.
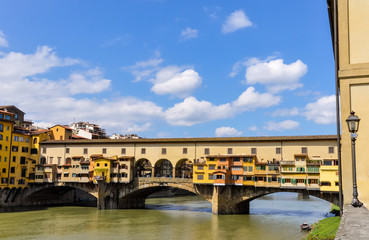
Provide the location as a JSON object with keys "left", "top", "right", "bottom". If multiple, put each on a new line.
{"left": 306, "top": 217, "right": 341, "bottom": 240}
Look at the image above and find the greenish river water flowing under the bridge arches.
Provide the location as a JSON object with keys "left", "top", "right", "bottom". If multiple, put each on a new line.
{"left": 0, "top": 193, "right": 330, "bottom": 240}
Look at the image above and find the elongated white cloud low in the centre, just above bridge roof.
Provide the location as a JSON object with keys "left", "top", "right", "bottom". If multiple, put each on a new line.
{"left": 165, "top": 97, "right": 233, "bottom": 126}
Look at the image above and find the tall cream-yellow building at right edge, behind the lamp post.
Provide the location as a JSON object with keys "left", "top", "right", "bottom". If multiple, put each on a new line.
{"left": 328, "top": 0, "right": 369, "bottom": 208}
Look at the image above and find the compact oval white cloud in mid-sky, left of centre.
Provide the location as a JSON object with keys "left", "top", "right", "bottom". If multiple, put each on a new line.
{"left": 151, "top": 66, "right": 202, "bottom": 97}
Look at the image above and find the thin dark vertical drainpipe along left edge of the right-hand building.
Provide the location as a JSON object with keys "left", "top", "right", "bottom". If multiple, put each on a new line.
{"left": 333, "top": 0, "right": 343, "bottom": 216}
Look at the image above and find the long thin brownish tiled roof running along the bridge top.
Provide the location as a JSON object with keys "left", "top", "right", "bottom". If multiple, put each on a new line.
{"left": 42, "top": 135, "right": 337, "bottom": 144}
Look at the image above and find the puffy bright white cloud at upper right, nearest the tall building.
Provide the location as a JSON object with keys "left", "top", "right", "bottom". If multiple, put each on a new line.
{"left": 245, "top": 59, "right": 307, "bottom": 93}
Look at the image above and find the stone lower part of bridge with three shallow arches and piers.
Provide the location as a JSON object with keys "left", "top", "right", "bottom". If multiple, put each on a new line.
{"left": 0, "top": 177, "right": 339, "bottom": 214}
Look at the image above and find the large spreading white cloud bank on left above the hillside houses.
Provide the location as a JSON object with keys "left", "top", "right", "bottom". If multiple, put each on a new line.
{"left": 0, "top": 46, "right": 164, "bottom": 135}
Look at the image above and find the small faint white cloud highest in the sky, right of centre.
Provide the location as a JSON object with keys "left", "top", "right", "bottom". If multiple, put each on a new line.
{"left": 222, "top": 10, "right": 252, "bottom": 33}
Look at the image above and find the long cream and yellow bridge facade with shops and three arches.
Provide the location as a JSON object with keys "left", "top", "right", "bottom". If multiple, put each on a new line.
{"left": 40, "top": 136, "right": 338, "bottom": 191}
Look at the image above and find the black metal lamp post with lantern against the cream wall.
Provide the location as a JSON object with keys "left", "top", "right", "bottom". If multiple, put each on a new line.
{"left": 346, "top": 111, "right": 363, "bottom": 207}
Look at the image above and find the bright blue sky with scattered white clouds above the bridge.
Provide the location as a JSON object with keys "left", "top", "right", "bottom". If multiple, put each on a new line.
{"left": 0, "top": 0, "right": 336, "bottom": 137}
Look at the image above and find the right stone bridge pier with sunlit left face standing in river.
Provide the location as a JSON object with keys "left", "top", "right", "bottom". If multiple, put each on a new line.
{"left": 212, "top": 186, "right": 250, "bottom": 215}
